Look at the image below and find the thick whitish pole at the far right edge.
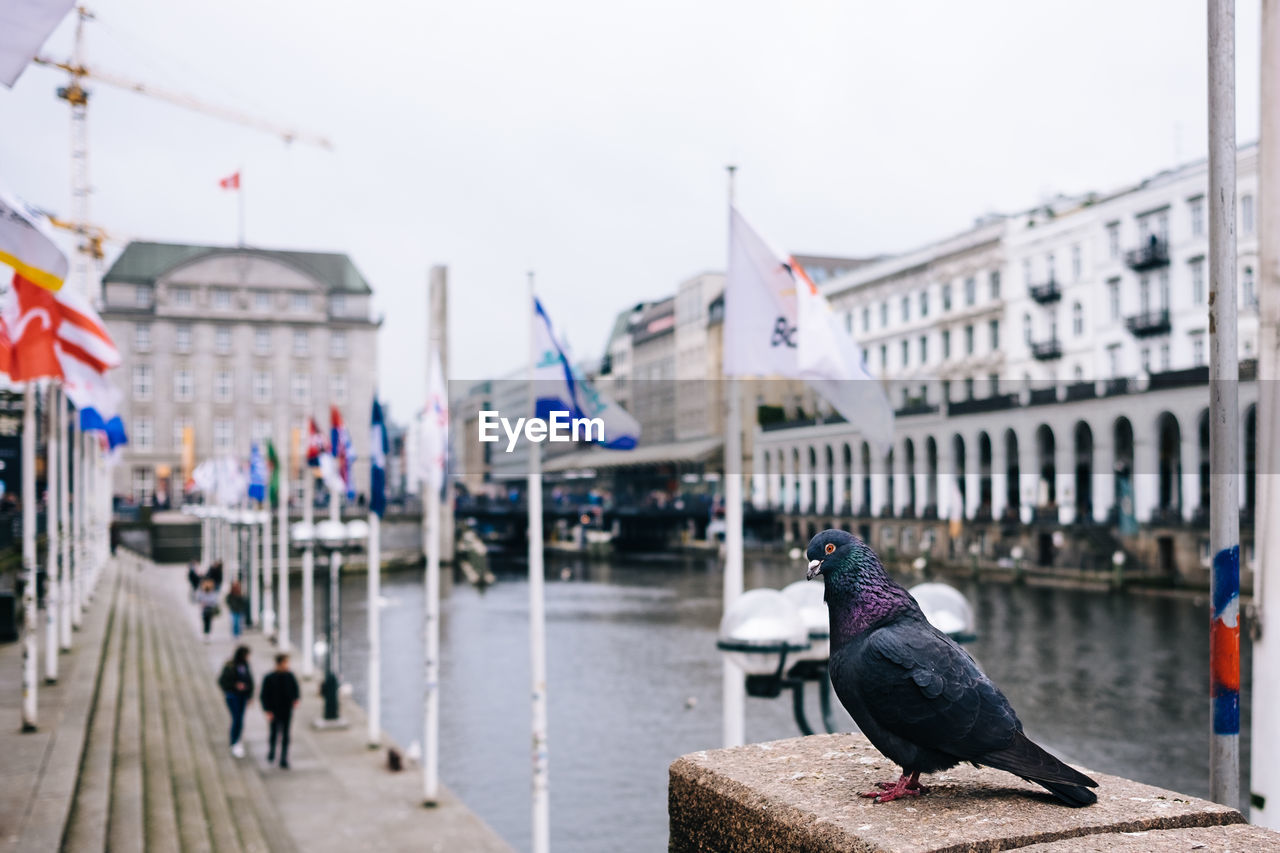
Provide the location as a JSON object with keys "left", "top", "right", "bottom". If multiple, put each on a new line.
{"left": 1249, "top": 0, "right": 1280, "bottom": 829}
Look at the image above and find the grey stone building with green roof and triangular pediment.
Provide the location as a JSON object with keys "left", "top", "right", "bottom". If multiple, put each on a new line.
{"left": 102, "top": 242, "right": 379, "bottom": 503}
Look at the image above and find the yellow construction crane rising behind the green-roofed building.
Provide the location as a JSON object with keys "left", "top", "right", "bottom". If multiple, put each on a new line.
{"left": 35, "top": 6, "right": 333, "bottom": 295}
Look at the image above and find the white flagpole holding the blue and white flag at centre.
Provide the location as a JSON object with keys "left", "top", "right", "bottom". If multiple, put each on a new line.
{"left": 526, "top": 273, "right": 550, "bottom": 853}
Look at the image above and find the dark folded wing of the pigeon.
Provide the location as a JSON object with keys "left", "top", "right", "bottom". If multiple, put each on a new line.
{"left": 858, "top": 617, "right": 1021, "bottom": 761}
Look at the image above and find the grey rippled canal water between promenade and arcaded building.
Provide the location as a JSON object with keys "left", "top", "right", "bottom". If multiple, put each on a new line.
{"left": 293, "top": 556, "right": 1251, "bottom": 853}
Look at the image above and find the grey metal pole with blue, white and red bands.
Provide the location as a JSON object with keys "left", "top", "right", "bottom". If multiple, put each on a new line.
{"left": 1208, "top": 0, "right": 1240, "bottom": 808}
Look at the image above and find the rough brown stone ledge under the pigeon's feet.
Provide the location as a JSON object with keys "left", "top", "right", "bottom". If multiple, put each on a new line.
{"left": 668, "top": 734, "right": 1249, "bottom": 853}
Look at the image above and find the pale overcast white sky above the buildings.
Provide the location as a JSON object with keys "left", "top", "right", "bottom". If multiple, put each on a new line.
{"left": 0, "top": 0, "right": 1258, "bottom": 418}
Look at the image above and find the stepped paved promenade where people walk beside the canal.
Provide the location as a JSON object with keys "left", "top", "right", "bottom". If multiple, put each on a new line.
{"left": 0, "top": 551, "right": 509, "bottom": 853}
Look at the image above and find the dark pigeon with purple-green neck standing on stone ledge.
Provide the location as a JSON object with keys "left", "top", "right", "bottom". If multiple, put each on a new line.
{"left": 805, "top": 530, "right": 1098, "bottom": 807}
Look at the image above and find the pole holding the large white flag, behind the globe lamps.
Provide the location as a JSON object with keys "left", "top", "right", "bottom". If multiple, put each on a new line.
{"left": 723, "top": 165, "right": 746, "bottom": 747}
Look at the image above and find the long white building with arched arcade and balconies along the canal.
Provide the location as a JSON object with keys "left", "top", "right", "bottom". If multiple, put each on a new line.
{"left": 751, "top": 146, "right": 1257, "bottom": 578}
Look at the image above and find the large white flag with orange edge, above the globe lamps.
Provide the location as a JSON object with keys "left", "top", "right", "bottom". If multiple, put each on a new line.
{"left": 724, "top": 207, "right": 893, "bottom": 450}
